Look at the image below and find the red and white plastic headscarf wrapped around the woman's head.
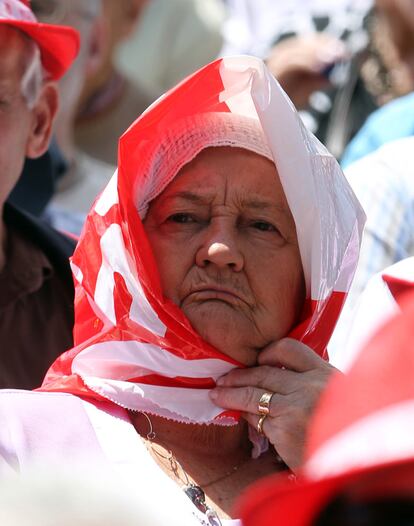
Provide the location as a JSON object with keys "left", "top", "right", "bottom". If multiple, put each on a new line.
{"left": 42, "top": 57, "right": 364, "bottom": 423}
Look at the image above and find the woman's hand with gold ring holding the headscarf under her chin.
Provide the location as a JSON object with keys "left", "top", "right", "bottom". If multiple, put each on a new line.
{"left": 211, "top": 338, "right": 337, "bottom": 470}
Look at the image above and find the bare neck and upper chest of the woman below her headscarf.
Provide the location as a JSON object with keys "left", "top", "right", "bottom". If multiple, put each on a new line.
{"left": 130, "top": 413, "right": 282, "bottom": 518}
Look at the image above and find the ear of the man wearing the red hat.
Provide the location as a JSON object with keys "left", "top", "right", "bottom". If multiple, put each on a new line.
{"left": 26, "top": 81, "right": 59, "bottom": 159}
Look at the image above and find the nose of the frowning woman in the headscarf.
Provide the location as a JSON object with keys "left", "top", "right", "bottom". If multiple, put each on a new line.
{"left": 196, "top": 226, "right": 244, "bottom": 272}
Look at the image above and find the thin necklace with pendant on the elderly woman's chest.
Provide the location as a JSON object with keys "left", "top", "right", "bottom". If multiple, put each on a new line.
{"left": 141, "top": 411, "right": 246, "bottom": 526}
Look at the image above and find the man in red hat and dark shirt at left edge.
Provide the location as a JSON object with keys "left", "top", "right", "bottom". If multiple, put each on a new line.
{"left": 0, "top": 0, "right": 79, "bottom": 388}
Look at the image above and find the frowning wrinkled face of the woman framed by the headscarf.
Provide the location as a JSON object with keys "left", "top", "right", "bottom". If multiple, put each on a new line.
{"left": 144, "top": 147, "right": 305, "bottom": 366}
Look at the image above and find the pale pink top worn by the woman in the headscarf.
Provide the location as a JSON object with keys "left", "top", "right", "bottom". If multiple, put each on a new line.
{"left": 0, "top": 390, "right": 240, "bottom": 526}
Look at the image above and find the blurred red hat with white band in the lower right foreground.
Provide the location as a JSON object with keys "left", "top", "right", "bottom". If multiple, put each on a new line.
{"left": 239, "top": 292, "right": 414, "bottom": 526}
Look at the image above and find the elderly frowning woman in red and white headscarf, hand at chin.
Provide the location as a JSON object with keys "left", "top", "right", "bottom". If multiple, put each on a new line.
{"left": 0, "top": 57, "right": 363, "bottom": 524}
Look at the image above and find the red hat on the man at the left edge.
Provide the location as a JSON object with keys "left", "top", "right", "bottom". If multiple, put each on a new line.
{"left": 0, "top": 0, "right": 80, "bottom": 80}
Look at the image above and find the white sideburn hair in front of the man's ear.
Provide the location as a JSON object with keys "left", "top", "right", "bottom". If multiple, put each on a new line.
{"left": 20, "top": 40, "right": 46, "bottom": 109}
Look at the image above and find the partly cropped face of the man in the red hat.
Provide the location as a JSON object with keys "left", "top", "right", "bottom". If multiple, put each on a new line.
{"left": 0, "top": 26, "right": 31, "bottom": 204}
